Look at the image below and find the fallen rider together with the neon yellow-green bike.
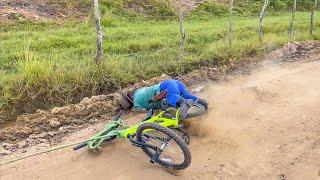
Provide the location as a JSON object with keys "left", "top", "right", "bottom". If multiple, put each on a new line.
{"left": 73, "top": 80, "right": 204, "bottom": 170}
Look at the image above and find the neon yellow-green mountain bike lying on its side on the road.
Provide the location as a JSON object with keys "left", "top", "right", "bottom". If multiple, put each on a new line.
{"left": 73, "top": 103, "right": 205, "bottom": 170}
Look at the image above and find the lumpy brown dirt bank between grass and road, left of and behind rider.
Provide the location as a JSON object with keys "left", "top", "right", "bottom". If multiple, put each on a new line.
{"left": 0, "top": 75, "right": 170, "bottom": 151}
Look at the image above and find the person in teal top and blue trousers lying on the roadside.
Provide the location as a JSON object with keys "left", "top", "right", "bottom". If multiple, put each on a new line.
{"left": 117, "top": 80, "right": 208, "bottom": 120}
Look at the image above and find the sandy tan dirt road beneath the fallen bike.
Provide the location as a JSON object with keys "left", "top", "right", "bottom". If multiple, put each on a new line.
{"left": 1, "top": 57, "right": 320, "bottom": 180}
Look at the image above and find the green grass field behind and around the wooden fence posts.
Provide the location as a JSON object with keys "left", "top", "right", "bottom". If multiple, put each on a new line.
{"left": 0, "top": 12, "right": 320, "bottom": 113}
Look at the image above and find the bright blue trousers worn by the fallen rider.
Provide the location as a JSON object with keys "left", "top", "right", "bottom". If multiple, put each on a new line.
{"left": 160, "top": 80, "right": 198, "bottom": 107}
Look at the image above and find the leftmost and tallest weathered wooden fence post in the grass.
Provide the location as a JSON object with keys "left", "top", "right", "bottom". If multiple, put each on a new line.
{"left": 93, "top": 0, "right": 103, "bottom": 64}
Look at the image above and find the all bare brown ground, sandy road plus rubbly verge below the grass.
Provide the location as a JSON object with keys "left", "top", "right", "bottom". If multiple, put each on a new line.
{"left": 1, "top": 42, "right": 320, "bottom": 179}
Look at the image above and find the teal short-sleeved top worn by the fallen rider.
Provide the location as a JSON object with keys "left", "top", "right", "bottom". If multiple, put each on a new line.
{"left": 133, "top": 84, "right": 161, "bottom": 109}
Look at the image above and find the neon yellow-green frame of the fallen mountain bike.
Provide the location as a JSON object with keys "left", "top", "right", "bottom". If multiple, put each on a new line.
{"left": 87, "top": 110, "right": 179, "bottom": 149}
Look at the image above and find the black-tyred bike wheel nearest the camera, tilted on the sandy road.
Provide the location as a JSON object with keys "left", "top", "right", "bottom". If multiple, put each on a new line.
{"left": 136, "top": 123, "right": 191, "bottom": 170}
